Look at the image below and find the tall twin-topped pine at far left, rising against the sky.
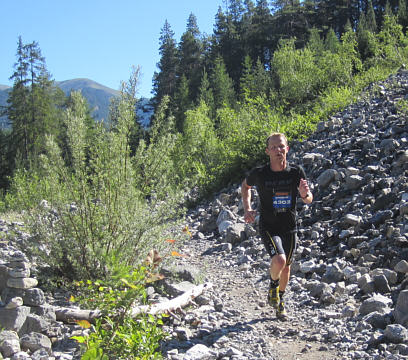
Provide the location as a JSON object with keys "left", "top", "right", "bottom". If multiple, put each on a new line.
{"left": 7, "top": 37, "right": 65, "bottom": 172}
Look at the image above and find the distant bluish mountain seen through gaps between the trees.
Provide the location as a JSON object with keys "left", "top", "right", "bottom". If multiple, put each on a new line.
{"left": 0, "top": 79, "right": 153, "bottom": 127}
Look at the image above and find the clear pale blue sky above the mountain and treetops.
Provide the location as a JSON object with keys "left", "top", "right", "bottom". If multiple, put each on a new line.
{"left": 0, "top": 0, "right": 223, "bottom": 97}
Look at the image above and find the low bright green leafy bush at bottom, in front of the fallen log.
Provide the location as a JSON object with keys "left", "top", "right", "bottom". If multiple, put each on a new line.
{"left": 71, "top": 266, "right": 165, "bottom": 360}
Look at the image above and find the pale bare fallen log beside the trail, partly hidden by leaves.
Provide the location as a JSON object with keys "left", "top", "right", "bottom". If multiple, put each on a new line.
{"left": 54, "top": 283, "right": 212, "bottom": 323}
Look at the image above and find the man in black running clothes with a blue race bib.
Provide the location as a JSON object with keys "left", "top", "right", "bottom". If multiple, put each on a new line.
{"left": 241, "top": 133, "right": 313, "bottom": 320}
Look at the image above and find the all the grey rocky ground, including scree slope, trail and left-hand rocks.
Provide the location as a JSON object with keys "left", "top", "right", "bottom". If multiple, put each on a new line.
{"left": 0, "top": 71, "right": 408, "bottom": 360}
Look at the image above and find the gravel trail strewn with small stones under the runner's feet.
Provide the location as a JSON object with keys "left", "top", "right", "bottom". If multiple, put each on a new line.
{"left": 160, "top": 222, "right": 341, "bottom": 359}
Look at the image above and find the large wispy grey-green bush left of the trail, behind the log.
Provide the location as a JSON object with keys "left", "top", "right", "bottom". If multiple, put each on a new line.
{"left": 4, "top": 90, "right": 183, "bottom": 279}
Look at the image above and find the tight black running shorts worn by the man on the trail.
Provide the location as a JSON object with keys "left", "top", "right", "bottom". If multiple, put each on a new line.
{"left": 259, "top": 222, "right": 297, "bottom": 265}
